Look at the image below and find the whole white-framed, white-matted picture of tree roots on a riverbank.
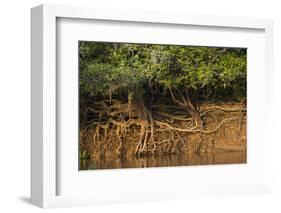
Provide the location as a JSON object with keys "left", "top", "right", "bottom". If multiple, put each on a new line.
{"left": 31, "top": 5, "right": 273, "bottom": 208}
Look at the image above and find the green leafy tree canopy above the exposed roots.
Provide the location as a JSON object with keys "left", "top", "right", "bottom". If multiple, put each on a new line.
{"left": 79, "top": 42, "right": 246, "bottom": 102}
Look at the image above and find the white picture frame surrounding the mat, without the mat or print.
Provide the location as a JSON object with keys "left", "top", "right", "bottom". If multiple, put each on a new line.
{"left": 31, "top": 5, "right": 273, "bottom": 208}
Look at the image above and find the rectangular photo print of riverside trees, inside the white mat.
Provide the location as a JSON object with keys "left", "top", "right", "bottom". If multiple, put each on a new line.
{"left": 78, "top": 41, "right": 247, "bottom": 170}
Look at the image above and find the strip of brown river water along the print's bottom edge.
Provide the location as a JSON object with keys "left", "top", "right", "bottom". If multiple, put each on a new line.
{"left": 80, "top": 152, "right": 247, "bottom": 170}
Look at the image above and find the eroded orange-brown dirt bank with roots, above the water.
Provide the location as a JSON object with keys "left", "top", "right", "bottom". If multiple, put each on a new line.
{"left": 80, "top": 101, "right": 246, "bottom": 161}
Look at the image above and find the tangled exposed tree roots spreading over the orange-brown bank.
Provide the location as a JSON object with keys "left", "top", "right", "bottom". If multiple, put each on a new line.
{"left": 80, "top": 100, "right": 245, "bottom": 157}
